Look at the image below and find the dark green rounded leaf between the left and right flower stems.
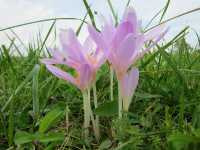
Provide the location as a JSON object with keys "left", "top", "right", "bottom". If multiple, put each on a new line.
{"left": 94, "top": 101, "right": 118, "bottom": 117}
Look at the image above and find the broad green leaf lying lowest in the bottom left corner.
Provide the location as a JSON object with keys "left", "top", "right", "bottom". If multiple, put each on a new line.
{"left": 14, "top": 131, "right": 35, "bottom": 145}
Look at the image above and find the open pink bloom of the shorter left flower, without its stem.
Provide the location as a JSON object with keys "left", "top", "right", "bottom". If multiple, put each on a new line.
{"left": 41, "top": 29, "right": 105, "bottom": 91}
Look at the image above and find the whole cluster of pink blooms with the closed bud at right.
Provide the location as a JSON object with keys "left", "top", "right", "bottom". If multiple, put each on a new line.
{"left": 41, "top": 8, "right": 166, "bottom": 139}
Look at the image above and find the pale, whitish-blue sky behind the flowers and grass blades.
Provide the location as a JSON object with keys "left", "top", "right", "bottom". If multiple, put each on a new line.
{"left": 0, "top": 0, "right": 200, "bottom": 49}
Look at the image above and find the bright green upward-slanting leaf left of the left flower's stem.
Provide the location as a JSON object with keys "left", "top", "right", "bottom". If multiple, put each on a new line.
{"left": 39, "top": 108, "right": 63, "bottom": 133}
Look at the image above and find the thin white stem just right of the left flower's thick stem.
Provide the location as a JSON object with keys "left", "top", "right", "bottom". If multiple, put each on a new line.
{"left": 92, "top": 83, "right": 100, "bottom": 140}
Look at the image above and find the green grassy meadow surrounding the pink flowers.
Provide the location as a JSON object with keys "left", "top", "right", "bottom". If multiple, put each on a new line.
{"left": 0, "top": 0, "right": 200, "bottom": 150}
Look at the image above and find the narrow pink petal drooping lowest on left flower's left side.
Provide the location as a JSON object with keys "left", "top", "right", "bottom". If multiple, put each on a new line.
{"left": 46, "top": 65, "right": 77, "bottom": 86}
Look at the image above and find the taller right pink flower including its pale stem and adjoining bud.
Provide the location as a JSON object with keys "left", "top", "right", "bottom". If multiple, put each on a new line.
{"left": 88, "top": 8, "right": 167, "bottom": 116}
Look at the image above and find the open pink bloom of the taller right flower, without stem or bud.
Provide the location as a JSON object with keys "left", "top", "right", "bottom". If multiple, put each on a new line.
{"left": 88, "top": 8, "right": 166, "bottom": 79}
